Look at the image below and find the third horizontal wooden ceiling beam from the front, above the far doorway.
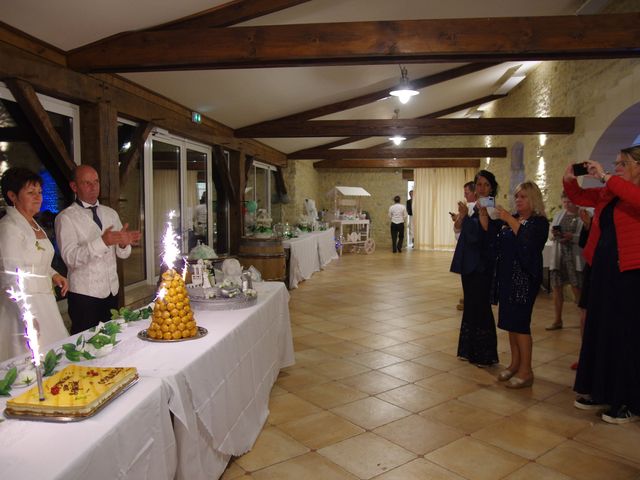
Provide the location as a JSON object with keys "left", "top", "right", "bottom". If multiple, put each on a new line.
{"left": 296, "top": 147, "right": 507, "bottom": 160}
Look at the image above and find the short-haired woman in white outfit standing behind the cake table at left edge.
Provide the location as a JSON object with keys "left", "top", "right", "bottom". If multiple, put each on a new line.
{"left": 0, "top": 168, "right": 69, "bottom": 362}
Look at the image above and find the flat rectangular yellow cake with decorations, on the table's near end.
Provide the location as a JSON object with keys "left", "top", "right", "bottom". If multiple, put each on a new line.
{"left": 6, "top": 365, "right": 138, "bottom": 417}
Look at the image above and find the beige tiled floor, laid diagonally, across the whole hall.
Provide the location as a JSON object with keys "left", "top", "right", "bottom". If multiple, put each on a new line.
{"left": 223, "top": 250, "right": 640, "bottom": 480}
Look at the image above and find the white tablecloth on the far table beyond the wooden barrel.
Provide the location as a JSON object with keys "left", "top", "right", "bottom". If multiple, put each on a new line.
{"left": 282, "top": 227, "right": 338, "bottom": 288}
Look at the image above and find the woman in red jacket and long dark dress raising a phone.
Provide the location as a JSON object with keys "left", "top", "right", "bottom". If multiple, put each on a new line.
{"left": 563, "top": 145, "right": 640, "bottom": 424}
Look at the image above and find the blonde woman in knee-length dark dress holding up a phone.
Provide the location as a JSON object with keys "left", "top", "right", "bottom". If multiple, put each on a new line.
{"left": 494, "top": 182, "right": 549, "bottom": 388}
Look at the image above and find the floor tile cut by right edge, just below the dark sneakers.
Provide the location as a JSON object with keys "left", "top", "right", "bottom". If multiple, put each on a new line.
{"left": 574, "top": 422, "right": 640, "bottom": 465}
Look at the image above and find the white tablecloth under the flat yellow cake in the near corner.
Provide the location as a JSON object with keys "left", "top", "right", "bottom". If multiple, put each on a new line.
{"left": 0, "top": 378, "right": 176, "bottom": 480}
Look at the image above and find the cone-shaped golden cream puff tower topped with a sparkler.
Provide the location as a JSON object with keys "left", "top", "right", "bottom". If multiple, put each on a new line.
{"left": 147, "top": 269, "right": 198, "bottom": 340}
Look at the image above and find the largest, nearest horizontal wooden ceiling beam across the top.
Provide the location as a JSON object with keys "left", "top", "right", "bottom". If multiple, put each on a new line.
{"left": 67, "top": 13, "right": 640, "bottom": 72}
